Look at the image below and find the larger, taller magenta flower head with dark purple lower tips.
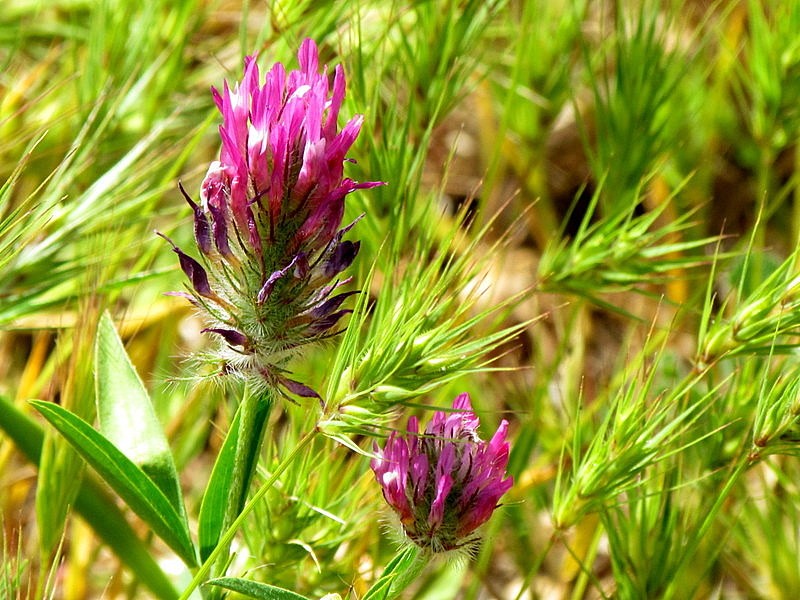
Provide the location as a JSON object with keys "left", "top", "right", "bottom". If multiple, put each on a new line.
{"left": 164, "top": 39, "right": 382, "bottom": 396}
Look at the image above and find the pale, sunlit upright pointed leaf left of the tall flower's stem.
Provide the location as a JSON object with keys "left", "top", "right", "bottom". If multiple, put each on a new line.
{"left": 95, "top": 312, "right": 186, "bottom": 520}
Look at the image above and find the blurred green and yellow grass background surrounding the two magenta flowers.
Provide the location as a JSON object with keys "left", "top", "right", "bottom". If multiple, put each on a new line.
{"left": 0, "top": 0, "right": 800, "bottom": 599}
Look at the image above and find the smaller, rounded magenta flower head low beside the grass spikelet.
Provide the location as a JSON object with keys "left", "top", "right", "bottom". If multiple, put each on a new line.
{"left": 371, "top": 394, "right": 513, "bottom": 552}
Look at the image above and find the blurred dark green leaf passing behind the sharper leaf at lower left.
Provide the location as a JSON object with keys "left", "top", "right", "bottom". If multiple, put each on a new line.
{"left": 0, "top": 396, "right": 178, "bottom": 600}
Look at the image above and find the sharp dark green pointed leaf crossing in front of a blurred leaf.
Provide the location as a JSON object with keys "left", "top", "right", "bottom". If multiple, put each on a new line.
{"left": 31, "top": 400, "right": 197, "bottom": 567}
